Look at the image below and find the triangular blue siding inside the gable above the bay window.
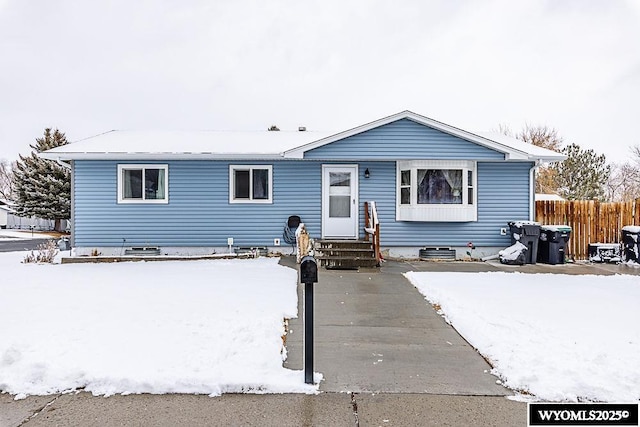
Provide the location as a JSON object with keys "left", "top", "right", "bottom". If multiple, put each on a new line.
{"left": 304, "top": 119, "right": 504, "bottom": 160}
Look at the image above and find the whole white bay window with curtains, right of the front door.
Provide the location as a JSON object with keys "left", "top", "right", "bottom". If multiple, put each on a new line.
{"left": 396, "top": 160, "right": 477, "bottom": 222}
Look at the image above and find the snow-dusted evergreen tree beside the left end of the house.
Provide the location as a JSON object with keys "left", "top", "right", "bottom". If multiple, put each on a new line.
{"left": 13, "top": 128, "right": 71, "bottom": 230}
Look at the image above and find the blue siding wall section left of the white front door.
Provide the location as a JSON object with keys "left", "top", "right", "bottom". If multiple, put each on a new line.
{"left": 74, "top": 161, "right": 321, "bottom": 247}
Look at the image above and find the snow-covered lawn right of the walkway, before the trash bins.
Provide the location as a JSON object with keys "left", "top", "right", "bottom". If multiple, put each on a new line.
{"left": 406, "top": 272, "right": 640, "bottom": 402}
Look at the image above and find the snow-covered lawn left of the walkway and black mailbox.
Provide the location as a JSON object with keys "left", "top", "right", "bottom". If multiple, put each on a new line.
{"left": 0, "top": 252, "right": 318, "bottom": 398}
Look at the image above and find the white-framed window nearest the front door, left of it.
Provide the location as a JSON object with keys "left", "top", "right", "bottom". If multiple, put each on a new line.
{"left": 229, "top": 165, "right": 273, "bottom": 203}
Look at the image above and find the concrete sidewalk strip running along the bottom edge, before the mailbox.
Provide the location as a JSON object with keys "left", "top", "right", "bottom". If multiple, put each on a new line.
{"left": 0, "top": 393, "right": 527, "bottom": 427}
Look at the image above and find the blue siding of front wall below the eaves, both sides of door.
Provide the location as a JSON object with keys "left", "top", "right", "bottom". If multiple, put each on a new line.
{"left": 73, "top": 161, "right": 532, "bottom": 247}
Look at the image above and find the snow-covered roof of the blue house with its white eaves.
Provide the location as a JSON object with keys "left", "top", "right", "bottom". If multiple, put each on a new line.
{"left": 41, "top": 111, "right": 566, "bottom": 161}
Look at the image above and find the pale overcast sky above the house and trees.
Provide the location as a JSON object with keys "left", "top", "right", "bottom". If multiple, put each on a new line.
{"left": 0, "top": 0, "right": 640, "bottom": 161}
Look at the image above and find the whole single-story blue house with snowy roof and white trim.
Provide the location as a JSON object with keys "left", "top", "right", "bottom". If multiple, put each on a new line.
{"left": 41, "top": 111, "right": 565, "bottom": 257}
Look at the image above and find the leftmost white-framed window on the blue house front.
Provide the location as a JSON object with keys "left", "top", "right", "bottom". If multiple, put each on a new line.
{"left": 118, "top": 164, "right": 169, "bottom": 203}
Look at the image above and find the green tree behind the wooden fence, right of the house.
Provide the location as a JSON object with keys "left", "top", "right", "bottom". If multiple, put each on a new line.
{"left": 553, "top": 144, "right": 611, "bottom": 200}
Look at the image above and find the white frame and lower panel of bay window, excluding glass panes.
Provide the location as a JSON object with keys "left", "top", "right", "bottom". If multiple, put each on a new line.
{"left": 396, "top": 160, "right": 478, "bottom": 222}
